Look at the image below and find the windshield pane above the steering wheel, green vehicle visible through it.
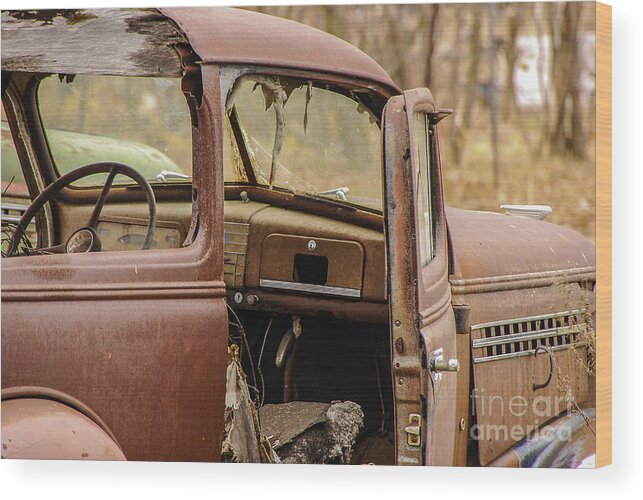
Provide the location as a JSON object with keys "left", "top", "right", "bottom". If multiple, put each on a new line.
{"left": 38, "top": 75, "right": 192, "bottom": 185}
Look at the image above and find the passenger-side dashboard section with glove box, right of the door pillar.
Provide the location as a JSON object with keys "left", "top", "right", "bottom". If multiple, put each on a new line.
{"left": 224, "top": 200, "right": 386, "bottom": 302}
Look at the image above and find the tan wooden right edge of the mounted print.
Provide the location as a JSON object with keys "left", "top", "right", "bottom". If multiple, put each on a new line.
{"left": 595, "top": 2, "right": 612, "bottom": 468}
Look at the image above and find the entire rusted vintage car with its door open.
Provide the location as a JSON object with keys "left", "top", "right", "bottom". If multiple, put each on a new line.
{"left": 2, "top": 8, "right": 595, "bottom": 467}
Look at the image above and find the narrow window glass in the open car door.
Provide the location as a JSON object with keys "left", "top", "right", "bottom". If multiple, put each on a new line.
{"left": 412, "top": 112, "right": 435, "bottom": 267}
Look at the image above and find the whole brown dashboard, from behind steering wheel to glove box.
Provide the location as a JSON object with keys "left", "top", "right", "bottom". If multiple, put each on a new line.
{"left": 54, "top": 198, "right": 388, "bottom": 322}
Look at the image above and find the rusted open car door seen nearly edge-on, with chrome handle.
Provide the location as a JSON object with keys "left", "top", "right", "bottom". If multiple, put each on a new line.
{"left": 383, "top": 89, "right": 466, "bottom": 465}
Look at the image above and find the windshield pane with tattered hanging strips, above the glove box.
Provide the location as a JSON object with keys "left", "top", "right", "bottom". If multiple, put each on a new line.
{"left": 225, "top": 75, "right": 382, "bottom": 210}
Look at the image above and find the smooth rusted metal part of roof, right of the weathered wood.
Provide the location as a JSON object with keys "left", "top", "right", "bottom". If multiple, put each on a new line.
{"left": 160, "top": 7, "right": 399, "bottom": 92}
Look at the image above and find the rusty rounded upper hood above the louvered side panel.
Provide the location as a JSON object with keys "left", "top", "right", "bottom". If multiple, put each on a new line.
{"left": 447, "top": 208, "right": 596, "bottom": 280}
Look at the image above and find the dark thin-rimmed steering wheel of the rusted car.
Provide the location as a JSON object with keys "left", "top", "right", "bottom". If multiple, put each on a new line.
{"left": 7, "top": 161, "right": 156, "bottom": 256}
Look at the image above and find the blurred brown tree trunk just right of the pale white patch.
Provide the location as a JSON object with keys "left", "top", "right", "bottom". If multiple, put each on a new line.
{"left": 550, "top": 2, "right": 585, "bottom": 158}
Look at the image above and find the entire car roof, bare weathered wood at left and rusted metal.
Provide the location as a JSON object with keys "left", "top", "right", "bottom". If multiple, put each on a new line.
{"left": 2, "top": 7, "right": 399, "bottom": 93}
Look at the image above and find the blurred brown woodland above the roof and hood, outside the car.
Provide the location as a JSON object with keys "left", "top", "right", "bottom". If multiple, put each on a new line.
{"left": 244, "top": 2, "right": 595, "bottom": 239}
